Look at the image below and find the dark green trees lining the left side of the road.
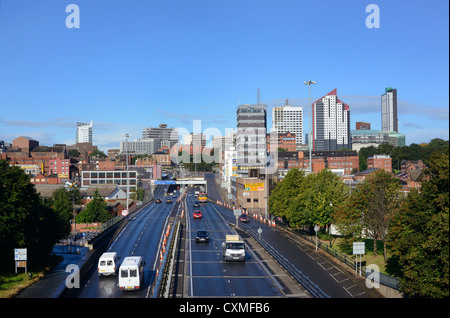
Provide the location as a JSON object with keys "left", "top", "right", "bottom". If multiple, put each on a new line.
{"left": 0, "top": 160, "right": 116, "bottom": 272}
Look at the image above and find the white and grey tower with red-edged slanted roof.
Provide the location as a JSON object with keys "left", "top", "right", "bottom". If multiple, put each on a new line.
{"left": 312, "top": 89, "right": 352, "bottom": 151}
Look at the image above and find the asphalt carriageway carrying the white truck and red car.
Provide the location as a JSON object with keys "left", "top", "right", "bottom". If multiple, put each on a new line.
{"left": 183, "top": 188, "right": 283, "bottom": 297}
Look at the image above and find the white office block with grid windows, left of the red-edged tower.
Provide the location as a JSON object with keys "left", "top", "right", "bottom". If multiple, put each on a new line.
{"left": 272, "top": 100, "right": 303, "bottom": 145}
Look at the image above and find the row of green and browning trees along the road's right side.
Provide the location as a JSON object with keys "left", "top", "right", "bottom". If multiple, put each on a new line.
{"left": 269, "top": 151, "right": 449, "bottom": 297}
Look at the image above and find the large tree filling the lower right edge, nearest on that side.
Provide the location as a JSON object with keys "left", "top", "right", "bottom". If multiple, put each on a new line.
{"left": 388, "top": 152, "right": 449, "bottom": 297}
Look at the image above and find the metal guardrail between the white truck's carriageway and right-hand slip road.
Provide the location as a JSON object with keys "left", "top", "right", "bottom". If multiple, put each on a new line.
{"left": 241, "top": 224, "right": 330, "bottom": 298}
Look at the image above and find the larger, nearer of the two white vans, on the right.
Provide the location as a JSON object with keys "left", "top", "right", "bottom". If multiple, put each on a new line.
{"left": 117, "top": 256, "right": 145, "bottom": 291}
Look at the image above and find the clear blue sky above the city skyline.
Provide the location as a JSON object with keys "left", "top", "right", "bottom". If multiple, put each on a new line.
{"left": 0, "top": 0, "right": 449, "bottom": 150}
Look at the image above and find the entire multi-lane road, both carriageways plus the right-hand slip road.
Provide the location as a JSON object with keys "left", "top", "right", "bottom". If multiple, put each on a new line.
{"left": 61, "top": 178, "right": 380, "bottom": 298}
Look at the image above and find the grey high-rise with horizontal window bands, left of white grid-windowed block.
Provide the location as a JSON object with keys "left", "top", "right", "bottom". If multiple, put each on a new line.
{"left": 236, "top": 104, "right": 267, "bottom": 177}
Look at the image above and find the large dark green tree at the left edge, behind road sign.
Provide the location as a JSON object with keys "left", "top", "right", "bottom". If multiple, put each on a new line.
{"left": 0, "top": 160, "right": 70, "bottom": 270}
